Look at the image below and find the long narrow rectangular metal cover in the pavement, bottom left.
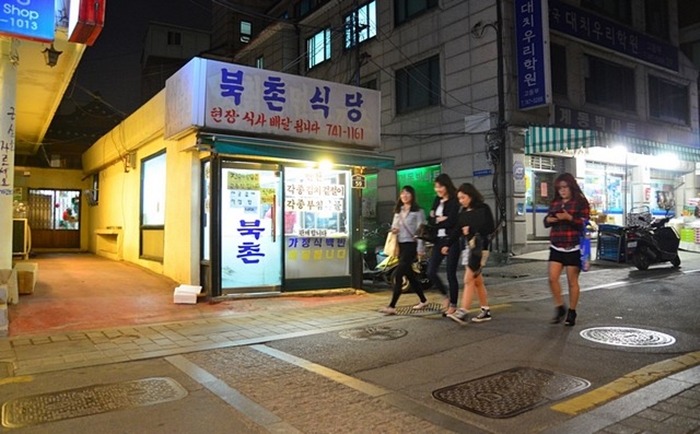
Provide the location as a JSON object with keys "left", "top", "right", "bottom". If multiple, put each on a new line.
{"left": 2, "top": 377, "right": 187, "bottom": 428}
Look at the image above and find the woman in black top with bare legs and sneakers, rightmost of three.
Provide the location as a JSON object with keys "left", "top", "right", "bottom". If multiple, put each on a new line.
{"left": 443, "top": 184, "right": 494, "bottom": 324}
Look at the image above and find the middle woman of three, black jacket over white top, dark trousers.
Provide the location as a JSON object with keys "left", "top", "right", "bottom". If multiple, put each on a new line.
{"left": 426, "top": 173, "right": 459, "bottom": 315}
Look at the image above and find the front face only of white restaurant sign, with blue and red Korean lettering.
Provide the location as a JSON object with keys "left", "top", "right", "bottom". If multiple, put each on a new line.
{"left": 204, "top": 60, "right": 380, "bottom": 146}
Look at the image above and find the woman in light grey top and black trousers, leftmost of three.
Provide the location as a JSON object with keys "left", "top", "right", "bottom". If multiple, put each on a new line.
{"left": 379, "top": 185, "right": 428, "bottom": 315}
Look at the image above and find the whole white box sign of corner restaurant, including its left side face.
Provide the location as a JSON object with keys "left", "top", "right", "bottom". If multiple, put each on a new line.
{"left": 166, "top": 59, "right": 380, "bottom": 148}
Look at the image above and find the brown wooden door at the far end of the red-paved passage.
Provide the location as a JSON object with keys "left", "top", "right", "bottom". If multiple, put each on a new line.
{"left": 27, "top": 188, "right": 81, "bottom": 249}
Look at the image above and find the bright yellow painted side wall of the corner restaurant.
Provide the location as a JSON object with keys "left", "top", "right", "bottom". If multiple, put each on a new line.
{"left": 83, "top": 92, "right": 201, "bottom": 284}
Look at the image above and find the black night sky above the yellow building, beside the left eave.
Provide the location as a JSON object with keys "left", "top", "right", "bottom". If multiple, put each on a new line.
{"left": 67, "top": 0, "right": 211, "bottom": 114}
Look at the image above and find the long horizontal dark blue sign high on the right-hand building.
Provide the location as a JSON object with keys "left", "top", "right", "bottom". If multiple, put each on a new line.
{"left": 549, "top": 0, "right": 678, "bottom": 71}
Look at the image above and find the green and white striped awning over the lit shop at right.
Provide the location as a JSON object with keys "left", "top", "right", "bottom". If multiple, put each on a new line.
{"left": 525, "top": 126, "right": 700, "bottom": 162}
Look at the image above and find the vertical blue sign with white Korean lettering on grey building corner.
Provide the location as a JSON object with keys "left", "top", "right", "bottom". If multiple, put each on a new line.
{"left": 515, "top": 0, "right": 551, "bottom": 109}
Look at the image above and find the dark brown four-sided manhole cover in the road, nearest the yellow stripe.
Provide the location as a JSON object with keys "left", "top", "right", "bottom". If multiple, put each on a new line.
{"left": 433, "top": 368, "right": 591, "bottom": 419}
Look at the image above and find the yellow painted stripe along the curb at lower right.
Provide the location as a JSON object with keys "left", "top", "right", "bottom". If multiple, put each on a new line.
{"left": 550, "top": 351, "right": 700, "bottom": 416}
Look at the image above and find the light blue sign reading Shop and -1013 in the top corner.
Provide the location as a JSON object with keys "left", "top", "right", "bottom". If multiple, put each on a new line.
{"left": 0, "top": 0, "right": 56, "bottom": 41}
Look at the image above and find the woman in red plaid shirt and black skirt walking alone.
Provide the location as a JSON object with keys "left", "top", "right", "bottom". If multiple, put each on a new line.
{"left": 544, "top": 173, "right": 590, "bottom": 326}
